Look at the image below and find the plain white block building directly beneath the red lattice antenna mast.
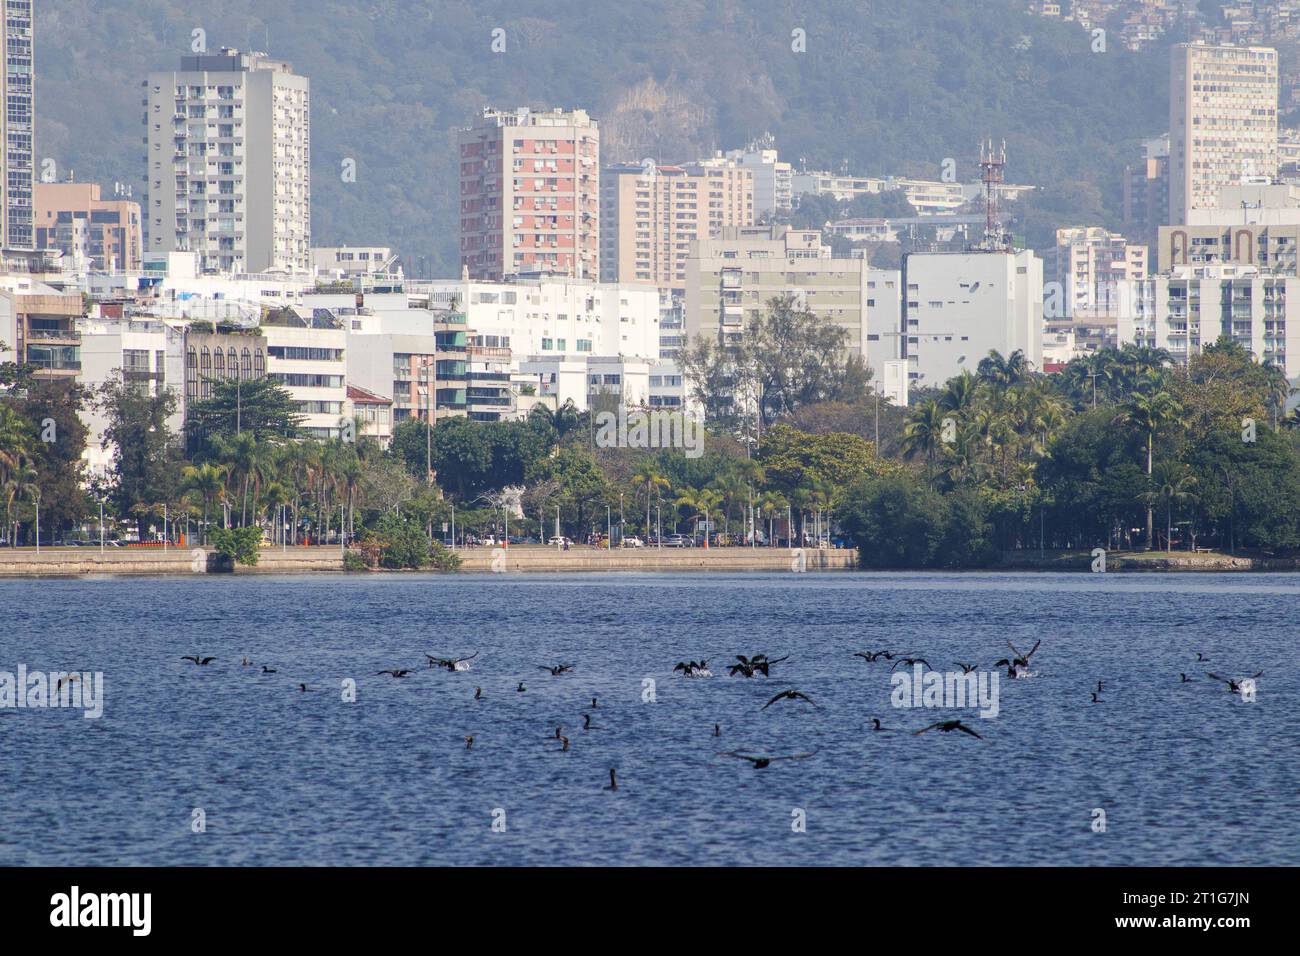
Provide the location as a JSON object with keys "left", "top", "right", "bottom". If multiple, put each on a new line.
{"left": 900, "top": 251, "right": 1044, "bottom": 388}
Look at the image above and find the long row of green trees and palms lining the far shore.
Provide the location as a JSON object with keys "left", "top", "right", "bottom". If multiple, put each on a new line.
{"left": 0, "top": 298, "right": 1300, "bottom": 567}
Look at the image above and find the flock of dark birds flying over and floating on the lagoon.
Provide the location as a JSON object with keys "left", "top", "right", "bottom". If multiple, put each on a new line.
{"left": 181, "top": 640, "right": 1264, "bottom": 791}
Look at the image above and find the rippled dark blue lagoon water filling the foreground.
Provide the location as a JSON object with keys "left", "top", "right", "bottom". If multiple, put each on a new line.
{"left": 0, "top": 574, "right": 1300, "bottom": 865}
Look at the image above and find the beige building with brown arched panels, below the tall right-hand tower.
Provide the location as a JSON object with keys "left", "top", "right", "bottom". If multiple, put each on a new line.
{"left": 1158, "top": 183, "right": 1300, "bottom": 276}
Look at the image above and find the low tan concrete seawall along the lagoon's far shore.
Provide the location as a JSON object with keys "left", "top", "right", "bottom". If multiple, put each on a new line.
{"left": 0, "top": 546, "right": 857, "bottom": 579}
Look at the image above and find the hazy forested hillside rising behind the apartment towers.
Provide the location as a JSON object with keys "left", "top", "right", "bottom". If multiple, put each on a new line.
{"left": 36, "top": 0, "right": 1167, "bottom": 274}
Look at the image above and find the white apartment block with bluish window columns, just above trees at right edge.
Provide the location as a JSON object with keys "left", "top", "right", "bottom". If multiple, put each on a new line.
{"left": 1118, "top": 264, "right": 1300, "bottom": 380}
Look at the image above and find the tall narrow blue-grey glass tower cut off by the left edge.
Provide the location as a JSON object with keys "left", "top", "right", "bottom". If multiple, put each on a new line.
{"left": 0, "top": 0, "right": 36, "bottom": 248}
